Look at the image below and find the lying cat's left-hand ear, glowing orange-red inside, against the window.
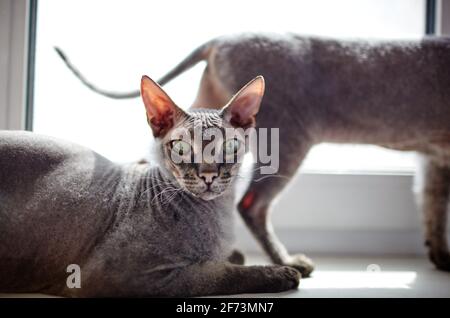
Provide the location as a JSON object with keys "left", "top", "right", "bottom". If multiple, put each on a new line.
{"left": 141, "top": 75, "right": 185, "bottom": 137}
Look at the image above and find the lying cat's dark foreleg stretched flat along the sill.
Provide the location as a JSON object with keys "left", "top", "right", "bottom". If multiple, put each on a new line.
{"left": 161, "top": 262, "right": 300, "bottom": 297}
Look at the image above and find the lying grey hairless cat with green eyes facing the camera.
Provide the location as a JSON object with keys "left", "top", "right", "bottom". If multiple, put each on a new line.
{"left": 0, "top": 77, "right": 300, "bottom": 297}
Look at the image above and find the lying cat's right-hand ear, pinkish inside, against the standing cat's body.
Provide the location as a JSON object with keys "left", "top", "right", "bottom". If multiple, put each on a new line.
{"left": 222, "top": 75, "right": 264, "bottom": 128}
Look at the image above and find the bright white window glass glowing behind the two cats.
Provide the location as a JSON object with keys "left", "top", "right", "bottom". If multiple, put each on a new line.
{"left": 34, "top": 0, "right": 425, "bottom": 173}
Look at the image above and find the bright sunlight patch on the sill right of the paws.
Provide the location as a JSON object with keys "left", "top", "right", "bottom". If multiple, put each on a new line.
{"left": 300, "top": 271, "right": 417, "bottom": 289}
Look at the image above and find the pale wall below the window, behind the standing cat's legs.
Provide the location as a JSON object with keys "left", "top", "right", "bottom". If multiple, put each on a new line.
{"left": 237, "top": 174, "right": 436, "bottom": 254}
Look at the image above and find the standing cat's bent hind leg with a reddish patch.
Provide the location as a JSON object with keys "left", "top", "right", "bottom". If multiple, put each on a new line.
{"left": 238, "top": 138, "right": 314, "bottom": 277}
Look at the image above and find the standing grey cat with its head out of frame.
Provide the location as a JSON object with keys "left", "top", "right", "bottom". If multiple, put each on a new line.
{"left": 59, "top": 34, "right": 450, "bottom": 276}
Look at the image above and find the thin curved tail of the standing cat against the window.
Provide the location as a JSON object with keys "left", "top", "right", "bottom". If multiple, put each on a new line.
{"left": 55, "top": 40, "right": 214, "bottom": 99}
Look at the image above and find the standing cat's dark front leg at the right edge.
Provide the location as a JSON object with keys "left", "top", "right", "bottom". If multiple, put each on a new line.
{"left": 422, "top": 160, "right": 450, "bottom": 271}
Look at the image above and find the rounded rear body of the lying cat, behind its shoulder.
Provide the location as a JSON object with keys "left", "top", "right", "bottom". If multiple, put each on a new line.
{"left": 0, "top": 131, "right": 121, "bottom": 292}
